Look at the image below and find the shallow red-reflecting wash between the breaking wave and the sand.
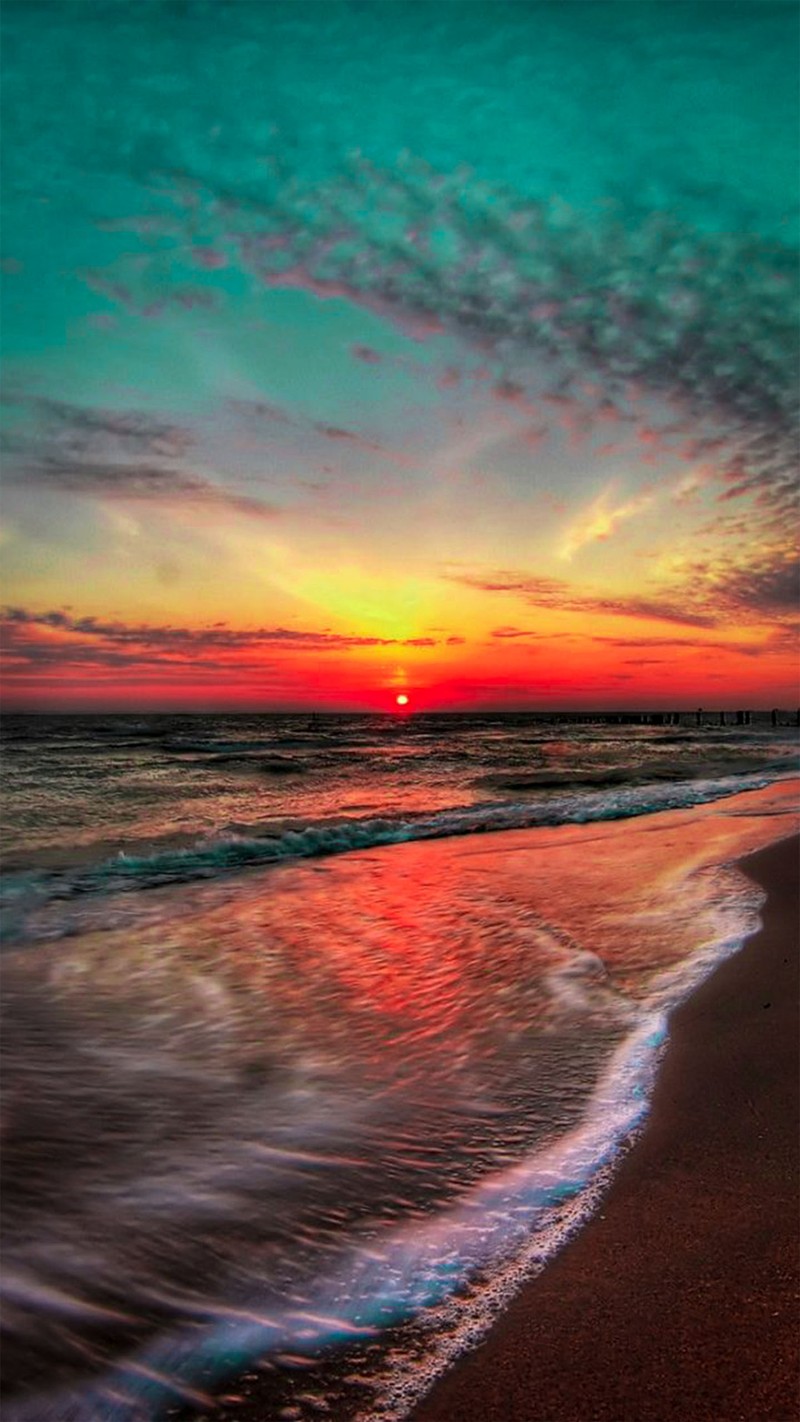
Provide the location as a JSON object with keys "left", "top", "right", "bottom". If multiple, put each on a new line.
{"left": 4, "top": 781, "right": 794, "bottom": 1419}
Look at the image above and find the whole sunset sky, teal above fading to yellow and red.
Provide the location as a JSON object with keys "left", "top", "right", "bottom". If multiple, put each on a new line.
{"left": 0, "top": 0, "right": 800, "bottom": 711}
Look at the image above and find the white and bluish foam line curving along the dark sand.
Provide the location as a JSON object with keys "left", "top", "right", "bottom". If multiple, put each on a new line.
{"left": 9, "top": 853, "right": 778, "bottom": 1422}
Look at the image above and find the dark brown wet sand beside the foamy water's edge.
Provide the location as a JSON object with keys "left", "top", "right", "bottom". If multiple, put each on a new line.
{"left": 412, "top": 839, "right": 800, "bottom": 1422}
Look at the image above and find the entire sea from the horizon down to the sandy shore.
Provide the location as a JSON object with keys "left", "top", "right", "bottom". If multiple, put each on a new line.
{"left": 1, "top": 712, "right": 797, "bottom": 1422}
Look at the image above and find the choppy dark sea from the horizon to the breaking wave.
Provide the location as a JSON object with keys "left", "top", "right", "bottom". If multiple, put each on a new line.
{"left": 0, "top": 712, "right": 797, "bottom": 943}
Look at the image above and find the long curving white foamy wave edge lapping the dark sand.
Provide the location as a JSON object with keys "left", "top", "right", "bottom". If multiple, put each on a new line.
{"left": 9, "top": 841, "right": 763, "bottom": 1422}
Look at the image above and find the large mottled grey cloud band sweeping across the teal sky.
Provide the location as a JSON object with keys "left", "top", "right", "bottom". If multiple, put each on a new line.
{"left": 117, "top": 155, "right": 799, "bottom": 514}
